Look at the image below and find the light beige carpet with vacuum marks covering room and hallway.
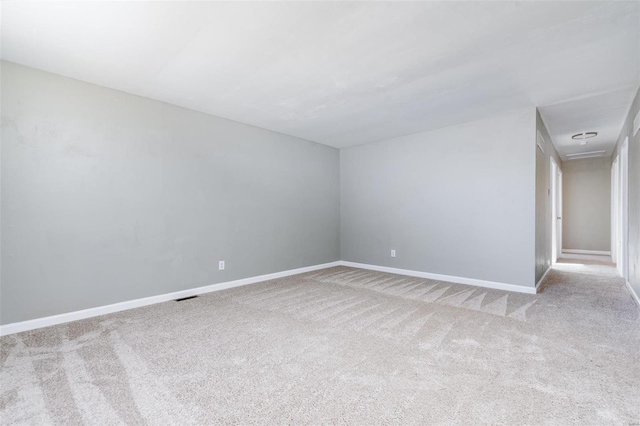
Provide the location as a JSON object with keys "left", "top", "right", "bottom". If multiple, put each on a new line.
{"left": 0, "top": 264, "right": 640, "bottom": 425}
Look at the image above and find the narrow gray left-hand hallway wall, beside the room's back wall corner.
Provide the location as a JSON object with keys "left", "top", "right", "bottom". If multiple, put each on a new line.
{"left": 534, "top": 111, "right": 561, "bottom": 283}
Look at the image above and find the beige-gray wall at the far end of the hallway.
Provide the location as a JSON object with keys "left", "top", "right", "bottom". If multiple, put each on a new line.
{"left": 562, "top": 157, "right": 611, "bottom": 251}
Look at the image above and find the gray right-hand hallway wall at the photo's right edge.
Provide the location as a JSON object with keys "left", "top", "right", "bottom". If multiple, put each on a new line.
{"left": 613, "top": 89, "right": 640, "bottom": 296}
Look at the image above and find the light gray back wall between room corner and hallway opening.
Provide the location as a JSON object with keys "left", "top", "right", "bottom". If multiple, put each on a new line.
{"left": 340, "top": 108, "right": 536, "bottom": 287}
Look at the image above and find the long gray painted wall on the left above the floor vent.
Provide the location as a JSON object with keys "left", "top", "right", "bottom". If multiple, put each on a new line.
{"left": 0, "top": 62, "right": 340, "bottom": 324}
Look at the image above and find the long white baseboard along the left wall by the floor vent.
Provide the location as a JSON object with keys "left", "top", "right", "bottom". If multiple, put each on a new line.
{"left": 0, "top": 261, "right": 341, "bottom": 336}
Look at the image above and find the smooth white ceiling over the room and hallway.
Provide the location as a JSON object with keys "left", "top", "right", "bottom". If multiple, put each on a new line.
{"left": 1, "top": 1, "right": 640, "bottom": 154}
